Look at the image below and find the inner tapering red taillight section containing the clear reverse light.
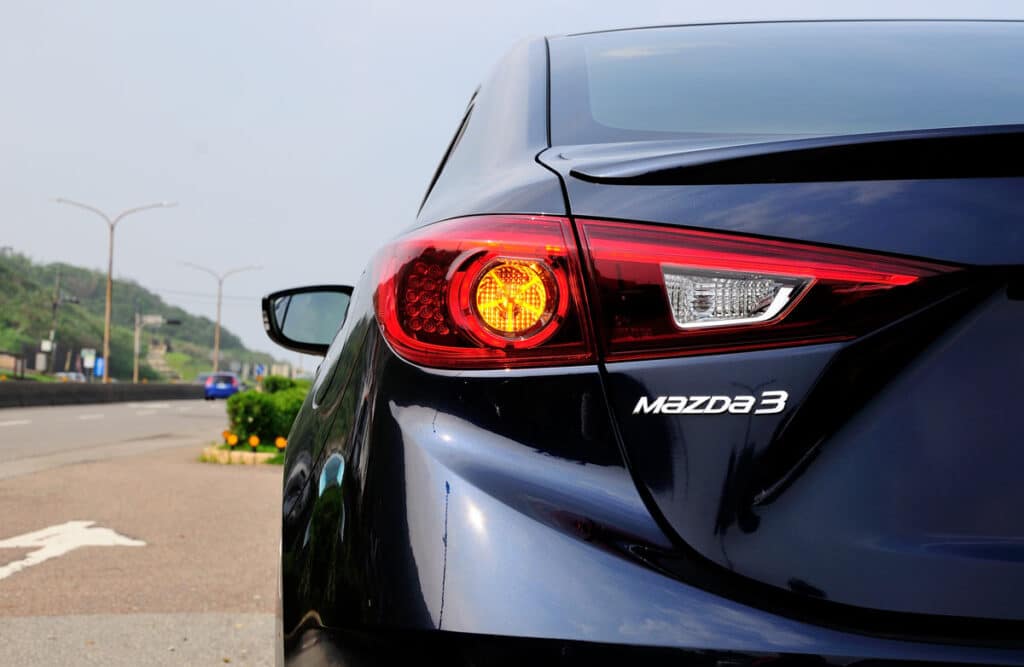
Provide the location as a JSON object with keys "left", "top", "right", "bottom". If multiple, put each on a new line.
{"left": 578, "top": 220, "right": 951, "bottom": 361}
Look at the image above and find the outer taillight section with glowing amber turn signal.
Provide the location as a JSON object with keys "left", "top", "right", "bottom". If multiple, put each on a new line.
{"left": 375, "top": 215, "right": 594, "bottom": 368}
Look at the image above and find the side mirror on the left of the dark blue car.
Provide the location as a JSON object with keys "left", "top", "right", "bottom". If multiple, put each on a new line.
{"left": 263, "top": 285, "right": 352, "bottom": 357}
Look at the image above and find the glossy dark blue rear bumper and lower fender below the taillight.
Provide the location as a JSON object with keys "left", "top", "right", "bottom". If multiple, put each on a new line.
{"left": 282, "top": 331, "right": 1024, "bottom": 665}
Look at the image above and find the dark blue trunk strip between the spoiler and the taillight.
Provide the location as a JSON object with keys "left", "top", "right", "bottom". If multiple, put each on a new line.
{"left": 541, "top": 171, "right": 1024, "bottom": 265}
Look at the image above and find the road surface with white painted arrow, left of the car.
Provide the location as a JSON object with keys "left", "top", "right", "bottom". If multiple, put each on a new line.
{"left": 0, "top": 401, "right": 281, "bottom": 666}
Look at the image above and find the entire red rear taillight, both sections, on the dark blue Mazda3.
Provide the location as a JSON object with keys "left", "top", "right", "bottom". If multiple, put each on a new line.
{"left": 375, "top": 215, "right": 953, "bottom": 368}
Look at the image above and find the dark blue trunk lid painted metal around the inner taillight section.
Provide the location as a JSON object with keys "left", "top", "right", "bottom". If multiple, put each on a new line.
{"left": 541, "top": 138, "right": 1024, "bottom": 621}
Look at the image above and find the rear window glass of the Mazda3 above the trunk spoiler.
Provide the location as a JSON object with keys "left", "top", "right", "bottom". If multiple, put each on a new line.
{"left": 551, "top": 22, "right": 1024, "bottom": 144}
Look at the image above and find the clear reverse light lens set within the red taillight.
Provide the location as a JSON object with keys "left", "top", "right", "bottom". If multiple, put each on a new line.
{"left": 662, "top": 264, "right": 810, "bottom": 329}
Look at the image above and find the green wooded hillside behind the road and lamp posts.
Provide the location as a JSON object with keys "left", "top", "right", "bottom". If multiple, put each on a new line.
{"left": 0, "top": 253, "right": 273, "bottom": 380}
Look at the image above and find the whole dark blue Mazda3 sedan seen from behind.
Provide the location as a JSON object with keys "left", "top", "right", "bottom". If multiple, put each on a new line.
{"left": 263, "top": 22, "right": 1024, "bottom": 665}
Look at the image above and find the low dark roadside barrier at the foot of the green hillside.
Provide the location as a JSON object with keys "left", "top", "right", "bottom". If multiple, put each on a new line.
{"left": 0, "top": 380, "right": 203, "bottom": 408}
